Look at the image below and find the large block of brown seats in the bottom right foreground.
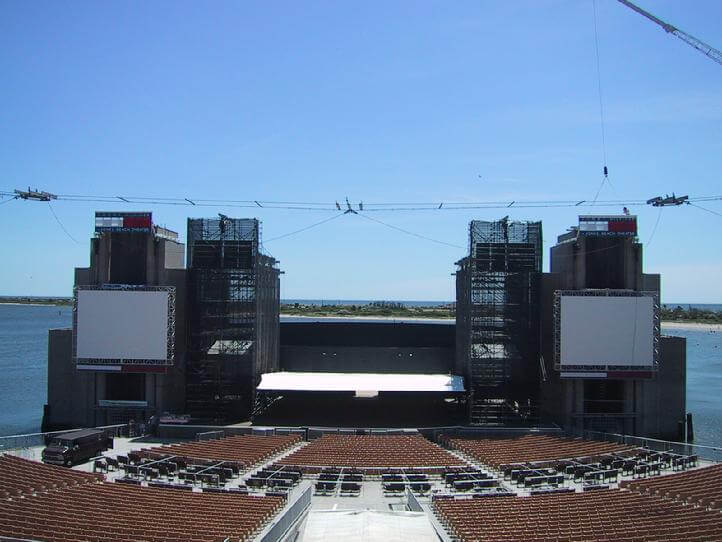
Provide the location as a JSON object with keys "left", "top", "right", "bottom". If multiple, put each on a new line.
{"left": 432, "top": 489, "right": 722, "bottom": 542}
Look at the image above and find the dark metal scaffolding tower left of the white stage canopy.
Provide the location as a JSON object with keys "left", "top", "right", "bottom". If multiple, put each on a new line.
{"left": 186, "top": 215, "right": 280, "bottom": 423}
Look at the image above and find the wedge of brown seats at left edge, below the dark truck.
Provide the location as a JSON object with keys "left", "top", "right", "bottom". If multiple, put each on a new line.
{"left": 0, "top": 454, "right": 103, "bottom": 498}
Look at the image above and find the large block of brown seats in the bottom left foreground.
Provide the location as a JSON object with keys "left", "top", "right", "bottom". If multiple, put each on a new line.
{"left": 0, "top": 461, "right": 285, "bottom": 542}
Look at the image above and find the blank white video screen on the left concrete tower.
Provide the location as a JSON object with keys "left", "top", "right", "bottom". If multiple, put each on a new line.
{"left": 76, "top": 290, "right": 168, "bottom": 360}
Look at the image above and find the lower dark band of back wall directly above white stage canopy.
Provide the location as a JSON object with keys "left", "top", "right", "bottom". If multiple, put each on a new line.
{"left": 281, "top": 348, "right": 454, "bottom": 374}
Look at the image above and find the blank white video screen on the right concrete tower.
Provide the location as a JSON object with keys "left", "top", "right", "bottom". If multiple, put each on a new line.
{"left": 560, "top": 295, "right": 654, "bottom": 367}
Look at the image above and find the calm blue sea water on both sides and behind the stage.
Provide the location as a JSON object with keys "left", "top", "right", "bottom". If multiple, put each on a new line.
{"left": 0, "top": 306, "right": 722, "bottom": 445}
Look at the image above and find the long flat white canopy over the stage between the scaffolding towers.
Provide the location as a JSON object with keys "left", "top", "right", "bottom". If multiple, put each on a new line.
{"left": 256, "top": 372, "right": 465, "bottom": 393}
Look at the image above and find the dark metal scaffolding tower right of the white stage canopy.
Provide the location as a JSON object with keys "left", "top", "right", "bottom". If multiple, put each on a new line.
{"left": 456, "top": 218, "right": 542, "bottom": 425}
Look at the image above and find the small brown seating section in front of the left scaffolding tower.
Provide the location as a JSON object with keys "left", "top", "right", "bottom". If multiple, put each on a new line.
{"left": 142, "top": 435, "right": 301, "bottom": 469}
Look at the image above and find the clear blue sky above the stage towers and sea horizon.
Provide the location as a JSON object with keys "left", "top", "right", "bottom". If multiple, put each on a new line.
{"left": 0, "top": 0, "right": 722, "bottom": 303}
